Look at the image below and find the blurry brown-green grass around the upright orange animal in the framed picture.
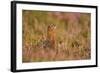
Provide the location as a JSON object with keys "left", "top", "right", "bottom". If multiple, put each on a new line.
{"left": 22, "top": 10, "right": 91, "bottom": 62}
